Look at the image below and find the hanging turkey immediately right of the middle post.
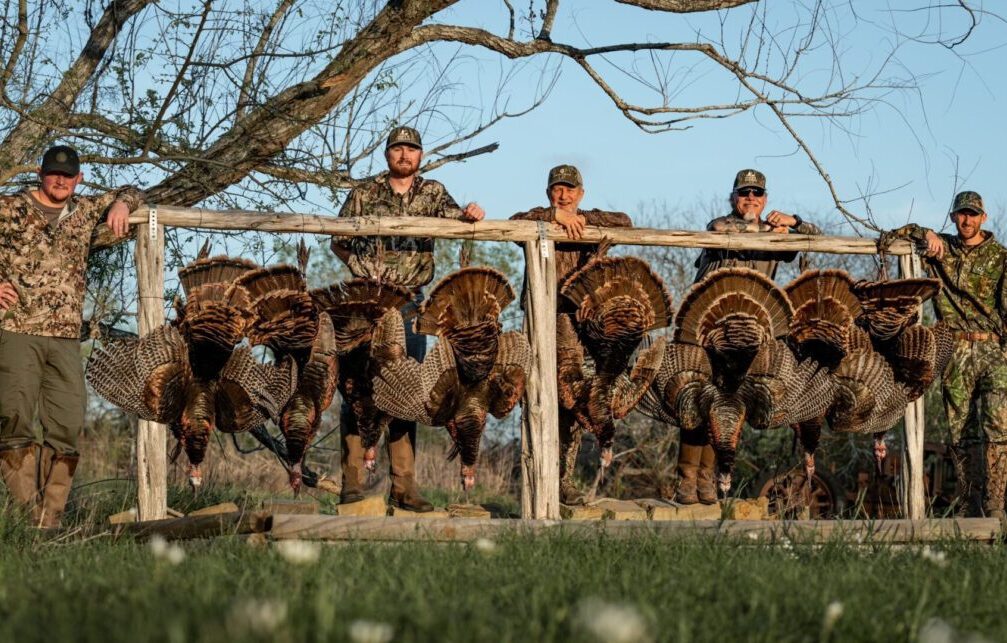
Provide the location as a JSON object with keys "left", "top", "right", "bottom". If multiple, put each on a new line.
{"left": 556, "top": 252, "right": 672, "bottom": 480}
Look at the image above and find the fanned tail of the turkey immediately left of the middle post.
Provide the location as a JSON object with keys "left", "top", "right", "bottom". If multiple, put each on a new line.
{"left": 416, "top": 268, "right": 515, "bottom": 335}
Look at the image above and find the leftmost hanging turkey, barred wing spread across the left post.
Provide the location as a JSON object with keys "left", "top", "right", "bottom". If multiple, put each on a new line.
{"left": 88, "top": 248, "right": 296, "bottom": 487}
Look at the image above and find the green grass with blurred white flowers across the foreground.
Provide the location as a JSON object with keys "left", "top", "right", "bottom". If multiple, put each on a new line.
{"left": 0, "top": 499, "right": 1007, "bottom": 643}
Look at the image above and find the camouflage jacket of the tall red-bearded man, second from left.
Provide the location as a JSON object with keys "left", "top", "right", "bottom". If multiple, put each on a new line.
{"left": 331, "top": 173, "right": 462, "bottom": 291}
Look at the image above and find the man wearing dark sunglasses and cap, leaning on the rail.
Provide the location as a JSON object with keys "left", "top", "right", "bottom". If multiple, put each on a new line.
{"left": 675, "top": 169, "right": 822, "bottom": 504}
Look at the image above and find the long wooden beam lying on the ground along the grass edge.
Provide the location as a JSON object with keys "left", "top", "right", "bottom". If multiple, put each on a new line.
{"left": 267, "top": 515, "right": 1003, "bottom": 544}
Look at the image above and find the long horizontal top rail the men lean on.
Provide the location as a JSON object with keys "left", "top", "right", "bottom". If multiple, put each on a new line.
{"left": 92, "top": 205, "right": 911, "bottom": 255}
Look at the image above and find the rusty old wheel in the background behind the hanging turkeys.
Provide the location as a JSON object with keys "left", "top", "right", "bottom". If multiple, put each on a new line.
{"left": 755, "top": 467, "right": 846, "bottom": 520}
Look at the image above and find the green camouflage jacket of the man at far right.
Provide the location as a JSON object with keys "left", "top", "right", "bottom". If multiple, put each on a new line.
{"left": 891, "top": 223, "right": 1007, "bottom": 338}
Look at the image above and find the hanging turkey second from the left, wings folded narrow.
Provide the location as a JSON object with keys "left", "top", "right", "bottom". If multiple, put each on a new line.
{"left": 234, "top": 242, "right": 338, "bottom": 495}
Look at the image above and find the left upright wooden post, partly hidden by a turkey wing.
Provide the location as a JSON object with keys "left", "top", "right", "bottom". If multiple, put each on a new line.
{"left": 136, "top": 219, "right": 168, "bottom": 520}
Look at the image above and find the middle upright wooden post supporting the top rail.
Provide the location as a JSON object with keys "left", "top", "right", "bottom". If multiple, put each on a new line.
{"left": 521, "top": 233, "right": 560, "bottom": 520}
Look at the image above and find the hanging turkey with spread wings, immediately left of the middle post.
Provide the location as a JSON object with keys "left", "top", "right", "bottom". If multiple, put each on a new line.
{"left": 372, "top": 268, "right": 532, "bottom": 491}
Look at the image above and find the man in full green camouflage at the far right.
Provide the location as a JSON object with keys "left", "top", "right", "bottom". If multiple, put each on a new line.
{"left": 882, "top": 192, "right": 1007, "bottom": 517}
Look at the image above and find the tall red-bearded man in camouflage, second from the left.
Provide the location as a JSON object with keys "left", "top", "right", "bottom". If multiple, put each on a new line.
{"left": 331, "top": 127, "right": 485, "bottom": 511}
